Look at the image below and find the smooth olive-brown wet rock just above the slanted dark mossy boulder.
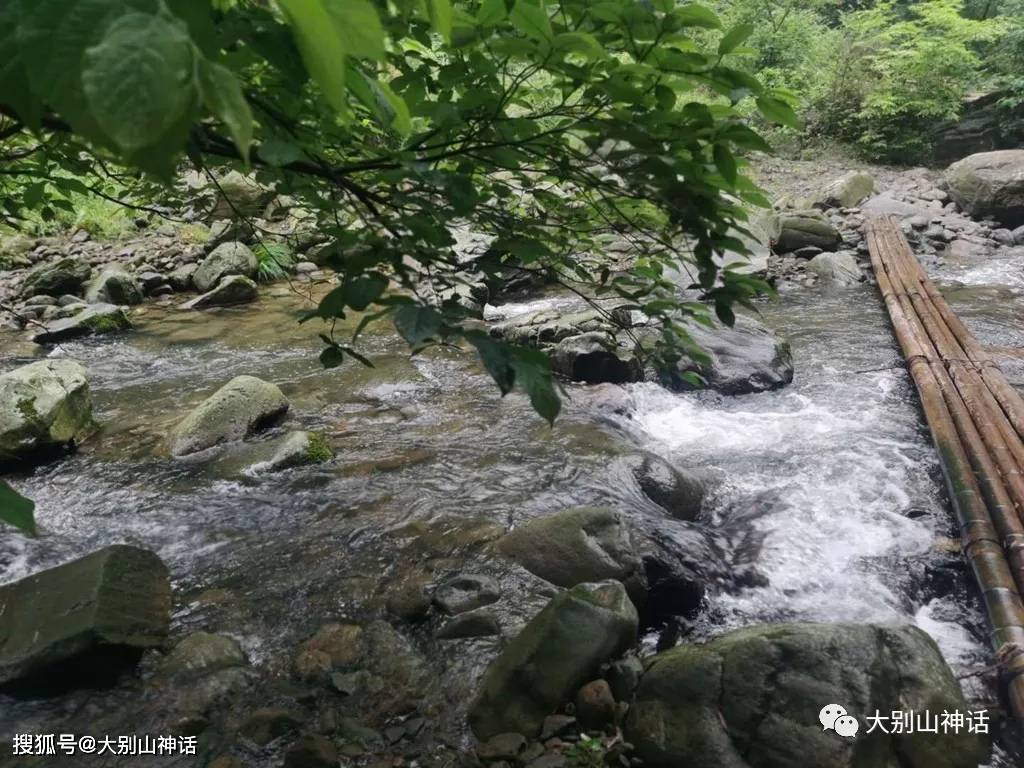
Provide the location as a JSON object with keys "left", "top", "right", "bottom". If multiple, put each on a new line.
{"left": 497, "top": 507, "right": 639, "bottom": 587}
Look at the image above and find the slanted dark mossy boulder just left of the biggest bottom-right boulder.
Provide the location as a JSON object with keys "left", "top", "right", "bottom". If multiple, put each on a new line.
{"left": 469, "top": 581, "right": 638, "bottom": 739}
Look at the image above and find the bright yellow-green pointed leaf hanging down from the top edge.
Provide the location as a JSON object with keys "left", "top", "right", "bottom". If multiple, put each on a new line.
{"left": 278, "top": 0, "right": 346, "bottom": 114}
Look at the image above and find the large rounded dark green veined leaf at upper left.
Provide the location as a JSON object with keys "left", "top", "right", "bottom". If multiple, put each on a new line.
{"left": 82, "top": 12, "right": 198, "bottom": 153}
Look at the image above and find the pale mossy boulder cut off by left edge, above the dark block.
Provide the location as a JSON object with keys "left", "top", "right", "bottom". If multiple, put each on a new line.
{"left": 0, "top": 359, "right": 94, "bottom": 464}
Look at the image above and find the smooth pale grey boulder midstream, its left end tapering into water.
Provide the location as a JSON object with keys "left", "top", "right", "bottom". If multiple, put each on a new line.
{"left": 171, "top": 376, "right": 289, "bottom": 456}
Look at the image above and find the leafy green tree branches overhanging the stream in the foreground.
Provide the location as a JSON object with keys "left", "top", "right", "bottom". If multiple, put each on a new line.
{"left": 0, "top": 0, "right": 796, "bottom": 428}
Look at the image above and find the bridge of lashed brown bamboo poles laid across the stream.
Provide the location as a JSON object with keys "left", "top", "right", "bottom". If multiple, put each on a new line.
{"left": 866, "top": 217, "right": 1024, "bottom": 719}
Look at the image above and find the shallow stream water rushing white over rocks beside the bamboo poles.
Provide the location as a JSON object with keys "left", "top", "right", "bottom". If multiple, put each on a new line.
{"left": 6, "top": 249, "right": 1024, "bottom": 765}
